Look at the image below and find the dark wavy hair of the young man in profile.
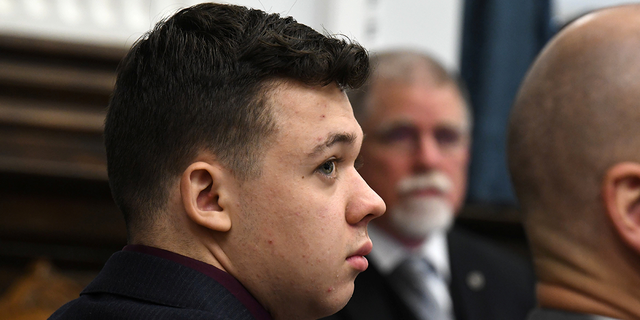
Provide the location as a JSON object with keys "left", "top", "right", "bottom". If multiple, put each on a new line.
{"left": 104, "top": 3, "right": 369, "bottom": 229}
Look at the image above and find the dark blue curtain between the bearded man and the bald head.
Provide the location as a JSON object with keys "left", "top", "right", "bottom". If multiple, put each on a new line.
{"left": 460, "top": 0, "right": 554, "bottom": 205}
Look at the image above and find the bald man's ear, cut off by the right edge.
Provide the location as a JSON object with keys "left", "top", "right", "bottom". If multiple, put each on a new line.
{"left": 603, "top": 162, "right": 640, "bottom": 253}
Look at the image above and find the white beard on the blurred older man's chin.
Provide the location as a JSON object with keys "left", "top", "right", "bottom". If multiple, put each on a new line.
{"left": 389, "top": 196, "right": 454, "bottom": 239}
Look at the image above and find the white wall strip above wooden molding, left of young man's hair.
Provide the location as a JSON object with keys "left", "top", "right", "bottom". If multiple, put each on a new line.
{"left": 0, "top": 0, "right": 195, "bottom": 46}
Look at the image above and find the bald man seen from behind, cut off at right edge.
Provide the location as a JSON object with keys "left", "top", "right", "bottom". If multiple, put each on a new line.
{"left": 508, "top": 5, "right": 640, "bottom": 320}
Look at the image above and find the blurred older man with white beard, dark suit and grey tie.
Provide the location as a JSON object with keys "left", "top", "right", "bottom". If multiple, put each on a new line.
{"left": 324, "top": 51, "right": 534, "bottom": 320}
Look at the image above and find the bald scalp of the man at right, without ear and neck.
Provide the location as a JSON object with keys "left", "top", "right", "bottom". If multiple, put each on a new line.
{"left": 508, "top": 6, "right": 640, "bottom": 222}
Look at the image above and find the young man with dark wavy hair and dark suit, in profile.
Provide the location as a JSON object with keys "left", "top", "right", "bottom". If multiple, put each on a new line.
{"left": 52, "top": 4, "right": 385, "bottom": 319}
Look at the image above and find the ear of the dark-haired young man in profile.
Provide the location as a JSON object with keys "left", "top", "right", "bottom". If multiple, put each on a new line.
{"left": 180, "top": 161, "right": 231, "bottom": 232}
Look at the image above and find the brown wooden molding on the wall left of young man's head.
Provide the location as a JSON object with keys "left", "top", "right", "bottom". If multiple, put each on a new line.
{"left": 0, "top": 36, "right": 126, "bottom": 181}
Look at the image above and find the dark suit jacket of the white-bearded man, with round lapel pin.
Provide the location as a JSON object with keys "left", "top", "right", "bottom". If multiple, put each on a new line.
{"left": 326, "top": 228, "right": 535, "bottom": 320}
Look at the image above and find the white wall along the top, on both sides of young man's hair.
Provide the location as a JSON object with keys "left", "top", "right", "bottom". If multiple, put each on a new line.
{"left": 0, "top": 0, "right": 462, "bottom": 68}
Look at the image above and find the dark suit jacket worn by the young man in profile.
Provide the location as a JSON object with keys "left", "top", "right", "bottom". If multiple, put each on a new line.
{"left": 49, "top": 251, "right": 254, "bottom": 320}
